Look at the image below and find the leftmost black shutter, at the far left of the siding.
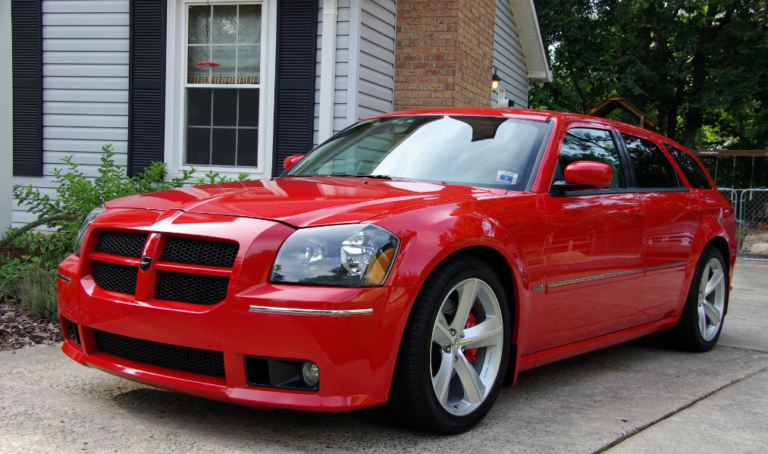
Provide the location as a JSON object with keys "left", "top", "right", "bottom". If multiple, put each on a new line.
{"left": 11, "top": 0, "right": 43, "bottom": 175}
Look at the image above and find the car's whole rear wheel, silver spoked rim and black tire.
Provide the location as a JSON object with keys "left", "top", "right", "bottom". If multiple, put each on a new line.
{"left": 665, "top": 247, "right": 728, "bottom": 352}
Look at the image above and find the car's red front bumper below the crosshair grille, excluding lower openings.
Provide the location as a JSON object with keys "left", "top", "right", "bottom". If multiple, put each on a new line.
{"left": 59, "top": 272, "right": 413, "bottom": 412}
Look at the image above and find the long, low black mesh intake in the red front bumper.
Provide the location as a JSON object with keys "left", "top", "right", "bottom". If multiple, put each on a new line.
{"left": 94, "top": 330, "right": 224, "bottom": 378}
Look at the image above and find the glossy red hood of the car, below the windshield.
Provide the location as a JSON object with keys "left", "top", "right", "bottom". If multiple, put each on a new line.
{"left": 106, "top": 177, "right": 506, "bottom": 227}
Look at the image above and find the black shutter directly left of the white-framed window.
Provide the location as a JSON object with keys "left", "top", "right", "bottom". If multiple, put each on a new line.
{"left": 128, "top": 0, "right": 167, "bottom": 175}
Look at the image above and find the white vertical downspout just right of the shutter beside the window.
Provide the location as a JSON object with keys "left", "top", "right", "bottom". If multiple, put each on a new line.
{"left": 318, "top": 0, "right": 338, "bottom": 143}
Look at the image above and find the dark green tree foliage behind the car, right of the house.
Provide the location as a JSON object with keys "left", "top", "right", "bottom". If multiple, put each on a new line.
{"left": 530, "top": 0, "right": 768, "bottom": 187}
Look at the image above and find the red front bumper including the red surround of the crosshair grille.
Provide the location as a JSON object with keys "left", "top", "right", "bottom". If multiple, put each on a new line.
{"left": 58, "top": 210, "right": 418, "bottom": 412}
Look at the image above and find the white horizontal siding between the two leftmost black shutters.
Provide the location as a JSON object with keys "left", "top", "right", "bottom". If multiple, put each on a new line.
{"left": 13, "top": 0, "right": 129, "bottom": 226}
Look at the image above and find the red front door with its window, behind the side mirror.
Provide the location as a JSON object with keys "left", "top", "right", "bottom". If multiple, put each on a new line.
{"left": 532, "top": 124, "right": 644, "bottom": 351}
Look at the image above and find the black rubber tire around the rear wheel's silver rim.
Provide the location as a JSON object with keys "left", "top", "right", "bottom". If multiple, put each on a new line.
{"left": 662, "top": 246, "right": 730, "bottom": 352}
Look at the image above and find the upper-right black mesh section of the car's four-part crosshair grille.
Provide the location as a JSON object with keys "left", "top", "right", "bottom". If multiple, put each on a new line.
{"left": 162, "top": 237, "right": 239, "bottom": 268}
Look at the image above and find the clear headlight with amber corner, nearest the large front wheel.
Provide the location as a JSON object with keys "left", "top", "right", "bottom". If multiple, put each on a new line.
{"left": 271, "top": 224, "right": 400, "bottom": 285}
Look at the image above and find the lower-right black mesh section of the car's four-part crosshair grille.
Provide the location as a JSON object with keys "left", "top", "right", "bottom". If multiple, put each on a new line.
{"left": 155, "top": 271, "right": 229, "bottom": 306}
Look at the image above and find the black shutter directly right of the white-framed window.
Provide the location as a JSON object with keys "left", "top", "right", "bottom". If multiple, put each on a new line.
{"left": 272, "top": 0, "right": 318, "bottom": 175}
